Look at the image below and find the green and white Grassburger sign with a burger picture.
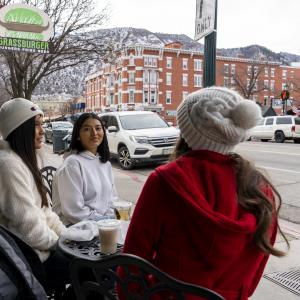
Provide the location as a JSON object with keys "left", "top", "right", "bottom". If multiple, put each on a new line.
{"left": 0, "top": 4, "right": 53, "bottom": 53}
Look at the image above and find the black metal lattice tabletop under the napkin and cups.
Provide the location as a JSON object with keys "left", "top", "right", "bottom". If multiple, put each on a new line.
{"left": 58, "top": 236, "right": 123, "bottom": 260}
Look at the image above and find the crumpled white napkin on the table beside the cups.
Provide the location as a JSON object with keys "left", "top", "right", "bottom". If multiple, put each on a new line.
{"left": 61, "top": 221, "right": 99, "bottom": 242}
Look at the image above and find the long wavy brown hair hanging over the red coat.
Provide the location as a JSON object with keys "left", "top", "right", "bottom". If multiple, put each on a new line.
{"left": 170, "top": 137, "right": 289, "bottom": 257}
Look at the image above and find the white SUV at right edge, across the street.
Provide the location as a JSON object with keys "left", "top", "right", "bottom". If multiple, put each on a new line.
{"left": 250, "top": 116, "right": 300, "bottom": 143}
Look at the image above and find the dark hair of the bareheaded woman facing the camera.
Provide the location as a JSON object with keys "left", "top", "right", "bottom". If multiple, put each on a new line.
{"left": 69, "top": 113, "right": 110, "bottom": 163}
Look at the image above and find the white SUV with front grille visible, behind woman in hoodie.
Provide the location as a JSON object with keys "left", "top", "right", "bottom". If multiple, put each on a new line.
{"left": 99, "top": 111, "right": 179, "bottom": 170}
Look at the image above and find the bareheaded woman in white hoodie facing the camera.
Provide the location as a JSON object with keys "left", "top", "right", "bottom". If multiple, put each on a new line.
{"left": 53, "top": 113, "right": 117, "bottom": 224}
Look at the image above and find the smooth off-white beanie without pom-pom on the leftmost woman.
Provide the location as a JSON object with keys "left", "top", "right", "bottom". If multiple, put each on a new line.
{"left": 0, "top": 98, "right": 43, "bottom": 140}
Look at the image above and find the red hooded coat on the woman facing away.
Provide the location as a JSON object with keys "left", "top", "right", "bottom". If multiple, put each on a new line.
{"left": 124, "top": 150, "right": 277, "bottom": 300}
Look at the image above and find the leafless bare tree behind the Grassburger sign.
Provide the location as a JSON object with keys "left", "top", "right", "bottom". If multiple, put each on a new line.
{"left": 0, "top": 0, "right": 109, "bottom": 99}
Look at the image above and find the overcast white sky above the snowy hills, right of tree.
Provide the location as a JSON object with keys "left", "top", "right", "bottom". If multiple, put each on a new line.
{"left": 96, "top": 0, "right": 300, "bottom": 55}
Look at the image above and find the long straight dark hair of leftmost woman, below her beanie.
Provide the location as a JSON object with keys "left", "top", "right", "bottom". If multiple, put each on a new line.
{"left": 6, "top": 117, "right": 49, "bottom": 207}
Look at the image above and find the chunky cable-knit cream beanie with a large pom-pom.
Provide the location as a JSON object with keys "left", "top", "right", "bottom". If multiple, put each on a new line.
{"left": 177, "top": 87, "right": 262, "bottom": 154}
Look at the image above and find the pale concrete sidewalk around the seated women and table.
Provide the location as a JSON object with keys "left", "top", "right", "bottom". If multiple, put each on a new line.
{"left": 44, "top": 144, "right": 300, "bottom": 300}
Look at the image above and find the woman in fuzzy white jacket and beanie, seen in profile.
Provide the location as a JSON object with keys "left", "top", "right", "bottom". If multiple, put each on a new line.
{"left": 0, "top": 98, "right": 70, "bottom": 292}
